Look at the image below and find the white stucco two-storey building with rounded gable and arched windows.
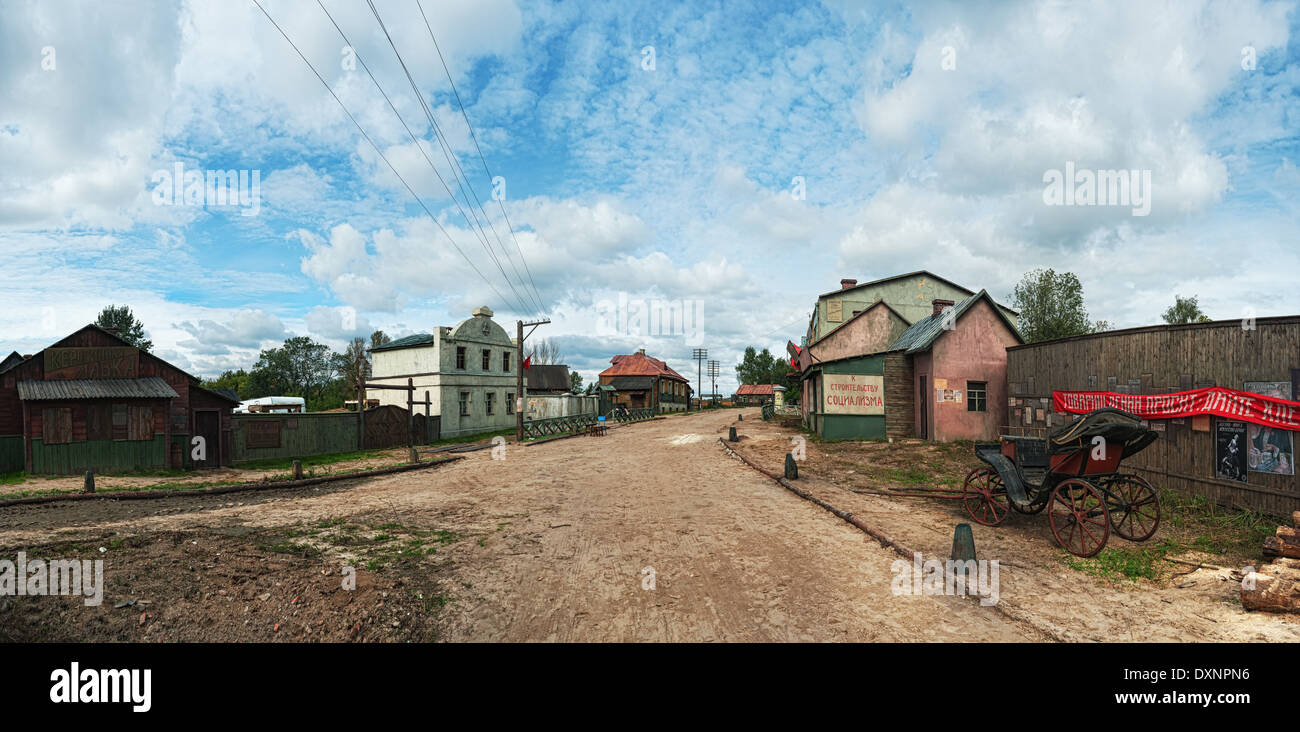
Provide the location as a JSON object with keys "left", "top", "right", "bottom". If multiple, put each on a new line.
{"left": 367, "top": 306, "right": 519, "bottom": 438}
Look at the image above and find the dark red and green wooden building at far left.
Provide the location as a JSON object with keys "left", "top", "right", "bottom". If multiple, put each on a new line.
{"left": 0, "top": 325, "right": 238, "bottom": 475}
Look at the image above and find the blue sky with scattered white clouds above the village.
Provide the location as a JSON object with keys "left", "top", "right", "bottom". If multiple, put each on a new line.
{"left": 0, "top": 0, "right": 1300, "bottom": 393}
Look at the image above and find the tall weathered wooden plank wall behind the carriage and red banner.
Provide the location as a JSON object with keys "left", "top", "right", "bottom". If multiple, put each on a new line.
{"left": 1006, "top": 317, "right": 1300, "bottom": 516}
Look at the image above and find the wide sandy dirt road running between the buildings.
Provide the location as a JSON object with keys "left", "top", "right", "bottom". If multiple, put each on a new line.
{"left": 0, "top": 410, "right": 1300, "bottom": 641}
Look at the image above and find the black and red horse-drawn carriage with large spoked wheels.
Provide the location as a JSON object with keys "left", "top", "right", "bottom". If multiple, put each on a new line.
{"left": 962, "top": 408, "right": 1160, "bottom": 556}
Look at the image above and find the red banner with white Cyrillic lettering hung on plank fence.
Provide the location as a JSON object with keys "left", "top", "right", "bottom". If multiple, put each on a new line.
{"left": 1052, "top": 386, "right": 1300, "bottom": 430}
